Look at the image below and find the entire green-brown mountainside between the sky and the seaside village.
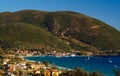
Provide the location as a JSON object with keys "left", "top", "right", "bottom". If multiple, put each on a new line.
{"left": 0, "top": 10, "right": 120, "bottom": 53}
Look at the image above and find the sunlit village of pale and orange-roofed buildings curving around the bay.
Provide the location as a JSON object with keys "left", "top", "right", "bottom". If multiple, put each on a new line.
{"left": 0, "top": 50, "right": 88, "bottom": 76}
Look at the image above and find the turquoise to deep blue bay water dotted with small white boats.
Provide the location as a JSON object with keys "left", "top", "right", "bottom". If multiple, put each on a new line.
{"left": 25, "top": 56, "right": 120, "bottom": 76}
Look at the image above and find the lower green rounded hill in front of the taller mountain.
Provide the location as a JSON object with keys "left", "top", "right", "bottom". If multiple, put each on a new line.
{"left": 0, "top": 22, "right": 70, "bottom": 51}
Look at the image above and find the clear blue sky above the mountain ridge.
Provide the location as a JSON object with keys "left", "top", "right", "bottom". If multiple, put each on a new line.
{"left": 0, "top": 0, "right": 120, "bottom": 31}
